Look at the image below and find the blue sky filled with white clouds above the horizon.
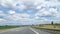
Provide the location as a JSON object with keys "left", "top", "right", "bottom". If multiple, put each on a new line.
{"left": 0, "top": 0, "right": 60, "bottom": 25}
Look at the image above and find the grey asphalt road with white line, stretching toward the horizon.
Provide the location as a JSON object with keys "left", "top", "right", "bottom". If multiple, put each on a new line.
{"left": 0, "top": 27, "right": 52, "bottom": 34}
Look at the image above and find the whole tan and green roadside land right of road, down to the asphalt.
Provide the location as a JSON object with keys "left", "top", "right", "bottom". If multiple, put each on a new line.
{"left": 34, "top": 24, "right": 60, "bottom": 34}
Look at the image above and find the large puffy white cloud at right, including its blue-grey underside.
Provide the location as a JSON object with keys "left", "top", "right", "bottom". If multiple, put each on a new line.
{"left": 35, "top": 5, "right": 60, "bottom": 21}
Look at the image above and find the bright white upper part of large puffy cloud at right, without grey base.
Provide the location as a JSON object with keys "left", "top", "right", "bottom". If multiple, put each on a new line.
{"left": 35, "top": 8, "right": 58, "bottom": 17}
